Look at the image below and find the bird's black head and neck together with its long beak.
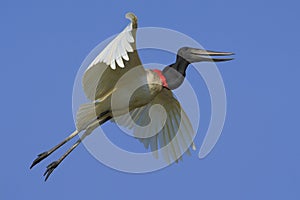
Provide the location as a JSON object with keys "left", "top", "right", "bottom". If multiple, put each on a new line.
{"left": 162, "top": 47, "right": 233, "bottom": 90}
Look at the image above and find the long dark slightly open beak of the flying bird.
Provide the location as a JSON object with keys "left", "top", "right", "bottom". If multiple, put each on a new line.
{"left": 186, "top": 48, "right": 234, "bottom": 63}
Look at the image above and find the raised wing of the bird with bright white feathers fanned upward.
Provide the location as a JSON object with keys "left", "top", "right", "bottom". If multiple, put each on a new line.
{"left": 82, "top": 13, "right": 145, "bottom": 101}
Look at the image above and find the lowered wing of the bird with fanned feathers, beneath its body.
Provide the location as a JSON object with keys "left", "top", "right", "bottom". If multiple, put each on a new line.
{"left": 115, "top": 88, "right": 195, "bottom": 163}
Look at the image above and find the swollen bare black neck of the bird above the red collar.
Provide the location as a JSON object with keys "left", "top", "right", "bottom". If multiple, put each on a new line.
{"left": 162, "top": 55, "right": 190, "bottom": 90}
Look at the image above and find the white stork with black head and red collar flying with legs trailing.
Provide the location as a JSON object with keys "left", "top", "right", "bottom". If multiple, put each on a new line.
{"left": 30, "top": 13, "right": 233, "bottom": 181}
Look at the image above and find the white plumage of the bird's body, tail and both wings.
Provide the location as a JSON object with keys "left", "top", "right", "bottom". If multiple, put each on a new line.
{"left": 77, "top": 14, "right": 195, "bottom": 162}
